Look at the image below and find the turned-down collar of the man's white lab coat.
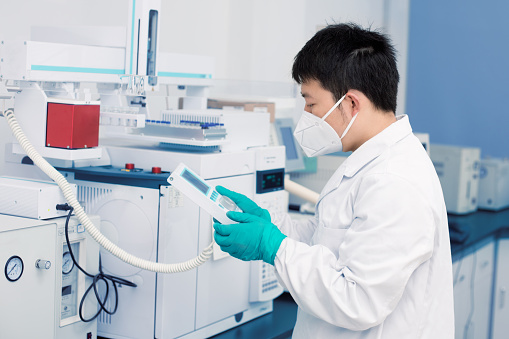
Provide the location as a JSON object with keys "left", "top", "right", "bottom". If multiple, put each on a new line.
{"left": 343, "top": 114, "right": 412, "bottom": 177}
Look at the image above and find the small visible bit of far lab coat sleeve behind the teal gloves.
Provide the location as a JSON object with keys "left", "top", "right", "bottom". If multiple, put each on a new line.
{"left": 270, "top": 212, "right": 318, "bottom": 244}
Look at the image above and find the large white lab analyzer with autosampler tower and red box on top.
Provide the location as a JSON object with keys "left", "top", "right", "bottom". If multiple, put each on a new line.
{"left": 0, "top": 1, "right": 288, "bottom": 338}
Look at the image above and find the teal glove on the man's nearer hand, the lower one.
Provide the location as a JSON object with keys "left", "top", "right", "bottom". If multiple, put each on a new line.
{"left": 214, "top": 211, "right": 286, "bottom": 265}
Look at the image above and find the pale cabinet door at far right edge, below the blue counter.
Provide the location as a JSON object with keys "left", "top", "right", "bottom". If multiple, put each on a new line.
{"left": 492, "top": 239, "right": 509, "bottom": 339}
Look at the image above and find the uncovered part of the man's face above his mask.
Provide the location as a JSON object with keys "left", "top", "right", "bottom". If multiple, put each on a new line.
{"left": 301, "top": 80, "right": 346, "bottom": 135}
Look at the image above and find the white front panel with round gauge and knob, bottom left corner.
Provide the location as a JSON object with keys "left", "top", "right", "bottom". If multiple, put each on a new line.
{"left": 0, "top": 214, "right": 58, "bottom": 338}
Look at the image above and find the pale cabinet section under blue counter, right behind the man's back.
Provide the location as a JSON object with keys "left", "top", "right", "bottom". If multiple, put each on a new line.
{"left": 453, "top": 241, "right": 495, "bottom": 339}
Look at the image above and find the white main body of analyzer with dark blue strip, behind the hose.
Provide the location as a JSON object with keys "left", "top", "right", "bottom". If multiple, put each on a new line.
{"left": 55, "top": 146, "right": 288, "bottom": 338}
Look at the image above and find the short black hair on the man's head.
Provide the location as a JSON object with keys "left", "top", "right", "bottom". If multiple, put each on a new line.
{"left": 292, "top": 23, "right": 399, "bottom": 113}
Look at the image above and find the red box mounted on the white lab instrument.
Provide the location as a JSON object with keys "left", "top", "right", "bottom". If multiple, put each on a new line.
{"left": 46, "top": 102, "right": 100, "bottom": 149}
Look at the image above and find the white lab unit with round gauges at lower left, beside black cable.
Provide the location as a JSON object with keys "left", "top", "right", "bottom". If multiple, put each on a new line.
{"left": 0, "top": 215, "right": 100, "bottom": 339}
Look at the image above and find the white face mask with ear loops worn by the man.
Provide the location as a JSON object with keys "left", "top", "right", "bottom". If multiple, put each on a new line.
{"left": 293, "top": 94, "right": 357, "bottom": 157}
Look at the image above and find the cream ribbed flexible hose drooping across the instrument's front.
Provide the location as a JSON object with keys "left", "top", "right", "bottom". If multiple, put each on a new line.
{"left": 4, "top": 109, "right": 214, "bottom": 273}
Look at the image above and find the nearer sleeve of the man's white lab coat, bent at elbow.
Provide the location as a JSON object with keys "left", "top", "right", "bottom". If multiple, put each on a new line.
{"left": 275, "top": 174, "right": 435, "bottom": 331}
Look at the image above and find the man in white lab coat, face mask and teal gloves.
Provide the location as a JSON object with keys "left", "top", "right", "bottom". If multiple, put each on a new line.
{"left": 214, "top": 24, "right": 454, "bottom": 339}
